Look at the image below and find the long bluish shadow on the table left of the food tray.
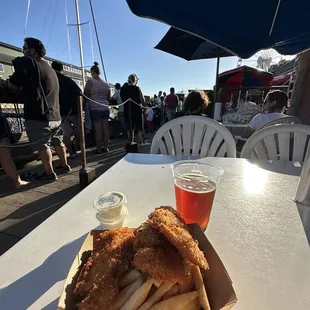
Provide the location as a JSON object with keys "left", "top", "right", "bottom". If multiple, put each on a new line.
{"left": 0, "top": 234, "right": 87, "bottom": 309}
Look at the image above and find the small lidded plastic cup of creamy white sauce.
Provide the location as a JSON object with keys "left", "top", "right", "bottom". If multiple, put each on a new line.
{"left": 94, "top": 192, "right": 128, "bottom": 230}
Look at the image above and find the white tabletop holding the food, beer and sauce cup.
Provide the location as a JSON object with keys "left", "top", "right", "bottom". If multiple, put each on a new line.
{"left": 0, "top": 154, "right": 310, "bottom": 310}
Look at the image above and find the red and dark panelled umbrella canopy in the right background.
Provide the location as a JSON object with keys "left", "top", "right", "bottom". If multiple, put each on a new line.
{"left": 218, "top": 66, "right": 273, "bottom": 87}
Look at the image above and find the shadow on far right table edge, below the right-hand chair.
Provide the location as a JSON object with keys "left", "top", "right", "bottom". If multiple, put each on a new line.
{"left": 247, "top": 159, "right": 301, "bottom": 176}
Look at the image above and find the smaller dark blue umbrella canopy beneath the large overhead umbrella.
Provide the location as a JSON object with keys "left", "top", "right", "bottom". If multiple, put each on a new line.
{"left": 155, "top": 27, "right": 235, "bottom": 60}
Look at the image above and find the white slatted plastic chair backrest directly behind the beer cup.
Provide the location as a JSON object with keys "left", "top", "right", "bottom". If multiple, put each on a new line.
{"left": 150, "top": 116, "right": 236, "bottom": 158}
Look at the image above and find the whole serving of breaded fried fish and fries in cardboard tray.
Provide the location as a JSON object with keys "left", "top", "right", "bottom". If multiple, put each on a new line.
{"left": 69, "top": 207, "right": 211, "bottom": 310}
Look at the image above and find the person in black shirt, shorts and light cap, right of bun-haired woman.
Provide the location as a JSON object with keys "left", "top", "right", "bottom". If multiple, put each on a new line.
{"left": 121, "top": 74, "right": 150, "bottom": 146}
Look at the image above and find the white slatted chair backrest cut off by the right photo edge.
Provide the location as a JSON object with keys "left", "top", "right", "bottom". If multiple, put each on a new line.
{"left": 241, "top": 124, "right": 310, "bottom": 162}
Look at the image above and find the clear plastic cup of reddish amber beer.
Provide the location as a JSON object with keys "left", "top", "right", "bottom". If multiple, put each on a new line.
{"left": 171, "top": 160, "right": 224, "bottom": 230}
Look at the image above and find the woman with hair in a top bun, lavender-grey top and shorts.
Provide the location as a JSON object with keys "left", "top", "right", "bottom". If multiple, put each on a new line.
{"left": 84, "top": 62, "right": 111, "bottom": 154}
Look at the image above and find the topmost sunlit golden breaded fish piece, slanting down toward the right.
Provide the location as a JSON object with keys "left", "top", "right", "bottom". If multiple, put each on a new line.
{"left": 148, "top": 207, "right": 209, "bottom": 269}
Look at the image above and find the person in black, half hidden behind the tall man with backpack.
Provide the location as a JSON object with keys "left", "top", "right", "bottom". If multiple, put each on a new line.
{"left": 52, "top": 61, "right": 81, "bottom": 158}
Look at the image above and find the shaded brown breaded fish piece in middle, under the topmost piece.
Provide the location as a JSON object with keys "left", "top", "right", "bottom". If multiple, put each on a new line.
{"left": 133, "top": 223, "right": 185, "bottom": 283}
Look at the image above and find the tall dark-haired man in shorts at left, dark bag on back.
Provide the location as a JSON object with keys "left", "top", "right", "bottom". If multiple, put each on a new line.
{"left": 7, "top": 38, "right": 71, "bottom": 182}
